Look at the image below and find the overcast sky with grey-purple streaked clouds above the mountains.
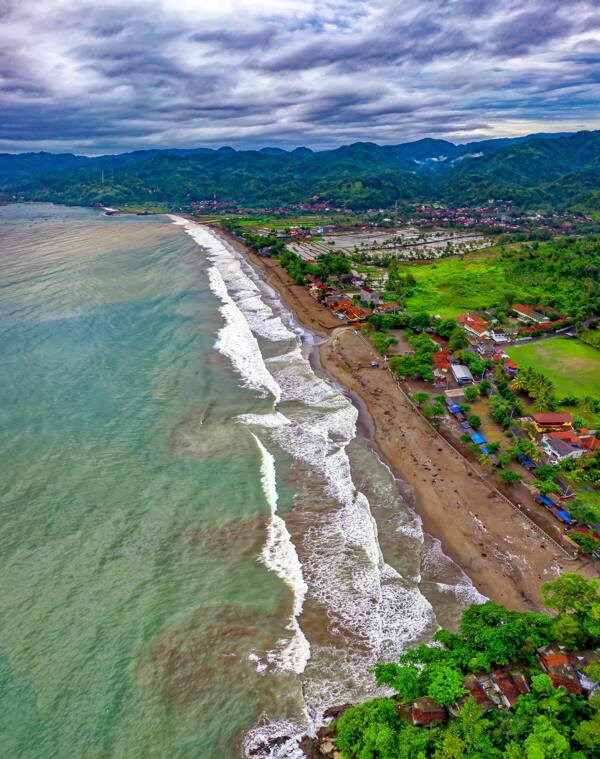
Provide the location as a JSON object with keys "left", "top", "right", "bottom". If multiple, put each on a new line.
{"left": 0, "top": 0, "right": 600, "bottom": 154}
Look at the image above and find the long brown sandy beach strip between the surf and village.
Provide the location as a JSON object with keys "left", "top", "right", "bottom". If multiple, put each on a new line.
{"left": 214, "top": 227, "right": 584, "bottom": 610}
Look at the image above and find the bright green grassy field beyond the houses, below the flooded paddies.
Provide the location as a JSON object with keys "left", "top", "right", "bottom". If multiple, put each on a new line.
{"left": 401, "top": 248, "right": 537, "bottom": 318}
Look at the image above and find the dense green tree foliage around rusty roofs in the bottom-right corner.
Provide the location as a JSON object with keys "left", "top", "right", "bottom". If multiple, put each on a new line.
{"left": 336, "top": 574, "right": 600, "bottom": 759}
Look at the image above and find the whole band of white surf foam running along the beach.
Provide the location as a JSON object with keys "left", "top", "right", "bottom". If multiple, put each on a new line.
{"left": 171, "top": 217, "right": 480, "bottom": 759}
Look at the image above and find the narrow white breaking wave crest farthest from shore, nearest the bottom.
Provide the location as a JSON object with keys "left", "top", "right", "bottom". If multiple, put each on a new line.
{"left": 252, "top": 434, "right": 310, "bottom": 674}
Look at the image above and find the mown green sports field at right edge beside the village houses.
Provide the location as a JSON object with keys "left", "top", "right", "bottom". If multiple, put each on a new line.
{"left": 506, "top": 337, "right": 600, "bottom": 398}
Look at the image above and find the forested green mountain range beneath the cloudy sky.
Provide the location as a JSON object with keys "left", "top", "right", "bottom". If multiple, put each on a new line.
{"left": 0, "top": 131, "right": 600, "bottom": 210}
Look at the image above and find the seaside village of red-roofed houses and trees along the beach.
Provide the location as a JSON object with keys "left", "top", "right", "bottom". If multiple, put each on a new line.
{"left": 245, "top": 233, "right": 600, "bottom": 559}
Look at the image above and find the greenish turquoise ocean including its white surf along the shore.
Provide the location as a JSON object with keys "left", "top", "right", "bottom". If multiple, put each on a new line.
{"left": 0, "top": 205, "right": 480, "bottom": 759}
